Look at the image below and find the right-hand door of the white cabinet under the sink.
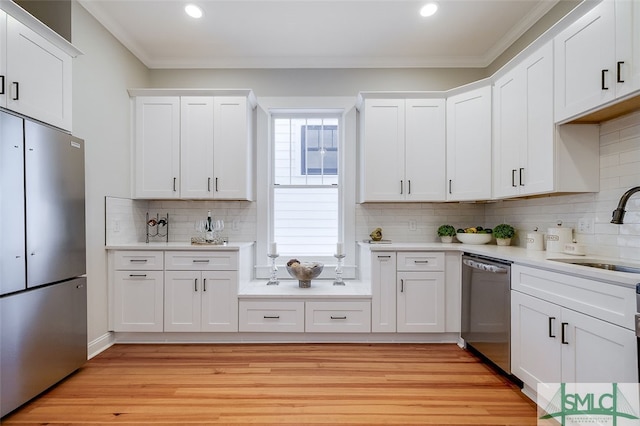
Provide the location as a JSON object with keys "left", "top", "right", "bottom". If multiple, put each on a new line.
{"left": 561, "top": 309, "right": 638, "bottom": 383}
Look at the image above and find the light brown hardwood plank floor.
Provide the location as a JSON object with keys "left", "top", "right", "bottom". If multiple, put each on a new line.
{"left": 1, "top": 344, "right": 537, "bottom": 426}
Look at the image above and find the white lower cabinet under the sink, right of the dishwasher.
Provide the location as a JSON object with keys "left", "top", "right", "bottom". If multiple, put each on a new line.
{"left": 511, "top": 266, "right": 638, "bottom": 391}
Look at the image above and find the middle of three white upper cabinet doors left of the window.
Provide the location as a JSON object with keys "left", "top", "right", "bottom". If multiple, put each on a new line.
{"left": 180, "top": 96, "right": 214, "bottom": 199}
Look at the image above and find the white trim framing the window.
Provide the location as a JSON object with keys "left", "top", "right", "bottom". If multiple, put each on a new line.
{"left": 256, "top": 96, "right": 357, "bottom": 279}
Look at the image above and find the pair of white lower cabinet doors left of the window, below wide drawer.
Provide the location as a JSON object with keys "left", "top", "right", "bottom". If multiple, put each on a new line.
{"left": 164, "top": 271, "right": 238, "bottom": 331}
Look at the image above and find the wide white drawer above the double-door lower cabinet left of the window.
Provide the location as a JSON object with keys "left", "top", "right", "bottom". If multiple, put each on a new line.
{"left": 164, "top": 251, "right": 238, "bottom": 271}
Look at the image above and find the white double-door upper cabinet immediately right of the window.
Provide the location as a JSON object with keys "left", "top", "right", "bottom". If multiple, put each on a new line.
{"left": 359, "top": 98, "right": 446, "bottom": 202}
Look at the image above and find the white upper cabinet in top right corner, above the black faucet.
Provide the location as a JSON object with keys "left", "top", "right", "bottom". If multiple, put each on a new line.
{"left": 554, "top": 0, "right": 640, "bottom": 122}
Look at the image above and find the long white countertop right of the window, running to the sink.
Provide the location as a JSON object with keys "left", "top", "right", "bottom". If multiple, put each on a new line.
{"left": 359, "top": 242, "right": 640, "bottom": 287}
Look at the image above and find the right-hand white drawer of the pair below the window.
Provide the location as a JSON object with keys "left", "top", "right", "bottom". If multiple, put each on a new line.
{"left": 305, "top": 301, "right": 371, "bottom": 333}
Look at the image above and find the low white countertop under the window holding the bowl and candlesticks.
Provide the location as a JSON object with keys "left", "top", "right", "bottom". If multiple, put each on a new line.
{"left": 238, "top": 279, "right": 371, "bottom": 299}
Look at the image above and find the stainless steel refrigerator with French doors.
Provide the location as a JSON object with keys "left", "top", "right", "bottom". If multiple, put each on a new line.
{"left": 0, "top": 110, "right": 87, "bottom": 417}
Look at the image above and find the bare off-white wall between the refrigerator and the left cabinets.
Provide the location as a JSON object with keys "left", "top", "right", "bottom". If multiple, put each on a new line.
{"left": 72, "top": 2, "right": 148, "bottom": 350}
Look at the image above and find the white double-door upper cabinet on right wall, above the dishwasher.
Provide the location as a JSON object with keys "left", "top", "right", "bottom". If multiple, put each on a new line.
{"left": 493, "top": 42, "right": 555, "bottom": 198}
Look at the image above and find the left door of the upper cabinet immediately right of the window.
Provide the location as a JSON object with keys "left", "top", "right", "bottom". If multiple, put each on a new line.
{"left": 359, "top": 99, "right": 406, "bottom": 202}
